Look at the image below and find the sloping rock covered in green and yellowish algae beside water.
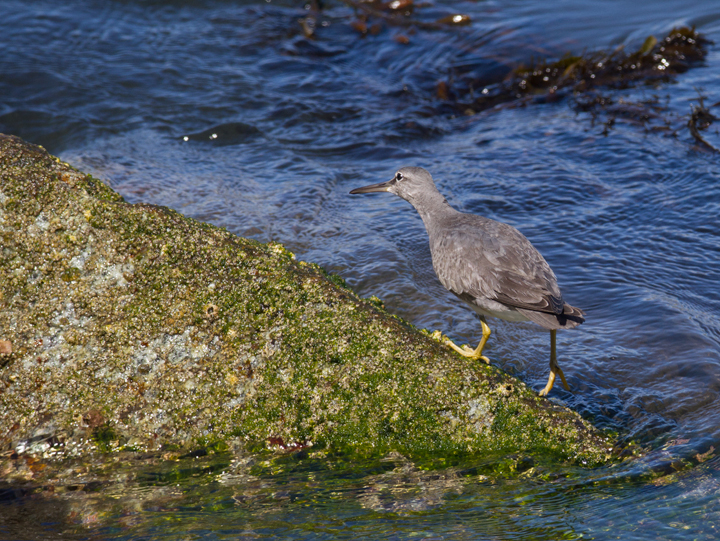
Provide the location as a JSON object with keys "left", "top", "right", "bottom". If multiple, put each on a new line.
{"left": 0, "top": 135, "right": 612, "bottom": 464}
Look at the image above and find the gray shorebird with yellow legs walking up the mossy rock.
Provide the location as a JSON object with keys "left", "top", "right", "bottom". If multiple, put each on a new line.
{"left": 350, "top": 167, "right": 585, "bottom": 396}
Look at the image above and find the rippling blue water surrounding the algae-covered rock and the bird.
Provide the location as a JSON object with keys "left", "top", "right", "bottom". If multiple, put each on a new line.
{"left": 0, "top": 0, "right": 720, "bottom": 539}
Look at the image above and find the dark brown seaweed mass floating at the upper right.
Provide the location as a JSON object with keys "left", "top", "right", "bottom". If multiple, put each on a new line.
{"left": 437, "top": 27, "right": 720, "bottom": 143}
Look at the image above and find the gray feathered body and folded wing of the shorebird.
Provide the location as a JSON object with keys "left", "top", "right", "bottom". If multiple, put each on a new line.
{"left": 430, "top": 214, "right": 564, "bottom": 314}
